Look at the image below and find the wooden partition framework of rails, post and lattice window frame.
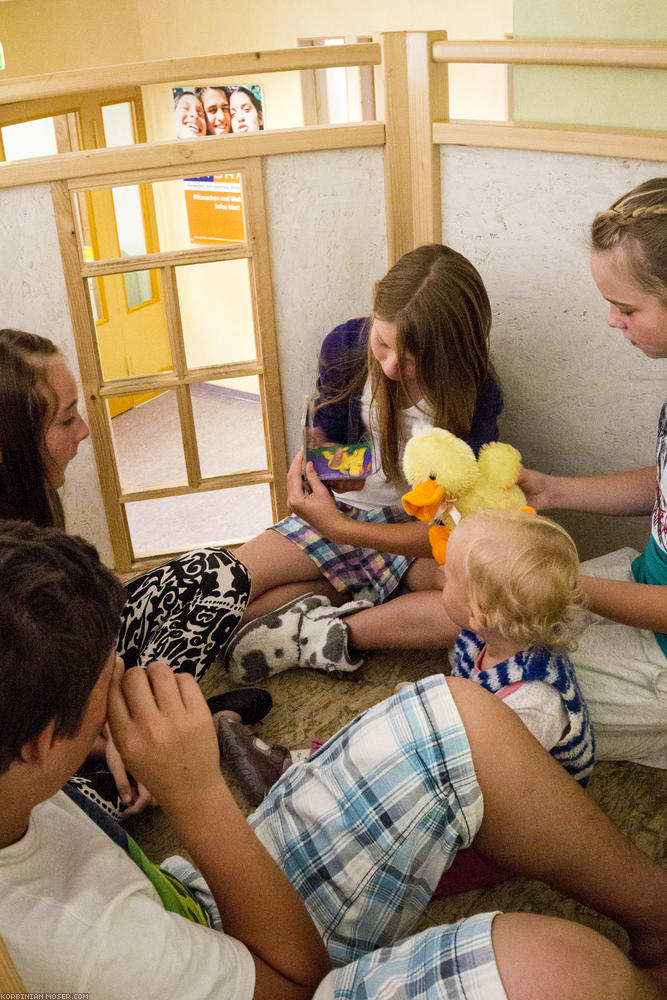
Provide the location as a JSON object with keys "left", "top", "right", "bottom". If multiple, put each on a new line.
{"left": 0, "top": 31, "right": 667, "bottom": 571}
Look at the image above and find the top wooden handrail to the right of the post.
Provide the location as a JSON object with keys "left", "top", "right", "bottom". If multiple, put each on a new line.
{"left": 433, "top": 39, "right": 667, "bottom": 69}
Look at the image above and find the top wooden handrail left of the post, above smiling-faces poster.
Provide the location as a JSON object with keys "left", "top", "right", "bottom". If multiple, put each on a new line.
{"left": 0, "top": 42, "right": 382, "bottom": 104}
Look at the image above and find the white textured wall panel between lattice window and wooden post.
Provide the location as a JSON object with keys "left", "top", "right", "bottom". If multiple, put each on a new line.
{"left": 264, "top": 148, "right": 387, "bottom": 456}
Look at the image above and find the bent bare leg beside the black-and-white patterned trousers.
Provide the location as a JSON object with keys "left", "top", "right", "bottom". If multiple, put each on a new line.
{"left": 234, "top": 530, "right": 345, "bottom": 622}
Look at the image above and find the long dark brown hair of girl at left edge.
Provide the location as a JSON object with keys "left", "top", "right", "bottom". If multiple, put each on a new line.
{"left": 0, "top": 330, "right": 65, "bottom": 527}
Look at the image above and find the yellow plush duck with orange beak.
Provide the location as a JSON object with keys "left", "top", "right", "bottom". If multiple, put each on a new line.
{"left": 402, "top": 427, "right": 534, "bottom": 565}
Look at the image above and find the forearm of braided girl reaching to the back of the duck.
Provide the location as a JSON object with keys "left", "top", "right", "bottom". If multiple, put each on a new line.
{"left": 518, "top": 465, "right": 656, "bottom": 515}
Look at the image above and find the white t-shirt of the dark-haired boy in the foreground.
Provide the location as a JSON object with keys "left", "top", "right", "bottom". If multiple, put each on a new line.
{"left": 0, "top": 792, "right": 255, "bottom": 1000}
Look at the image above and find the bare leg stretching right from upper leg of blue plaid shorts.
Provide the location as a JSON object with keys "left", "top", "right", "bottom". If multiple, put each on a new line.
{"left": 448, "top": 678, "right": 667, "bottom": 980}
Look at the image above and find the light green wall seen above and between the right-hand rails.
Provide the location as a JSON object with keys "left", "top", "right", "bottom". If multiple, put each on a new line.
{"left": 514, "top": 0, "right": 667, "bottom": 130}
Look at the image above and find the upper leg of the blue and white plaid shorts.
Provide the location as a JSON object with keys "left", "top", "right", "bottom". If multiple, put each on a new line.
{"left": 249, "top": 675, "right": 490, "bottom": 968}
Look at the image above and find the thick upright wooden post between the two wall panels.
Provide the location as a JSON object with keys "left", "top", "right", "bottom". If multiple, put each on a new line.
{"left": 382, "top": 31, "right": 449, "bottom": 265}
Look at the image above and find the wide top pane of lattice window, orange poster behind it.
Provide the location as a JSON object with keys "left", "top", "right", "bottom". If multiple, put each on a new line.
{"left": 78, "top": 173, "right": 245, "bottom": 260}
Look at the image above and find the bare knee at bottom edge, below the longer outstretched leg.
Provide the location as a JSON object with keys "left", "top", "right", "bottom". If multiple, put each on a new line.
{"left": 491, "top": 913, "right": 660, "bottom": 1000}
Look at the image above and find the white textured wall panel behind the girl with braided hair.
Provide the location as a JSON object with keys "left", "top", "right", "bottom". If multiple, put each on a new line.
{"left": 441, "top": 147, "right": 667, "bottom": 555}
